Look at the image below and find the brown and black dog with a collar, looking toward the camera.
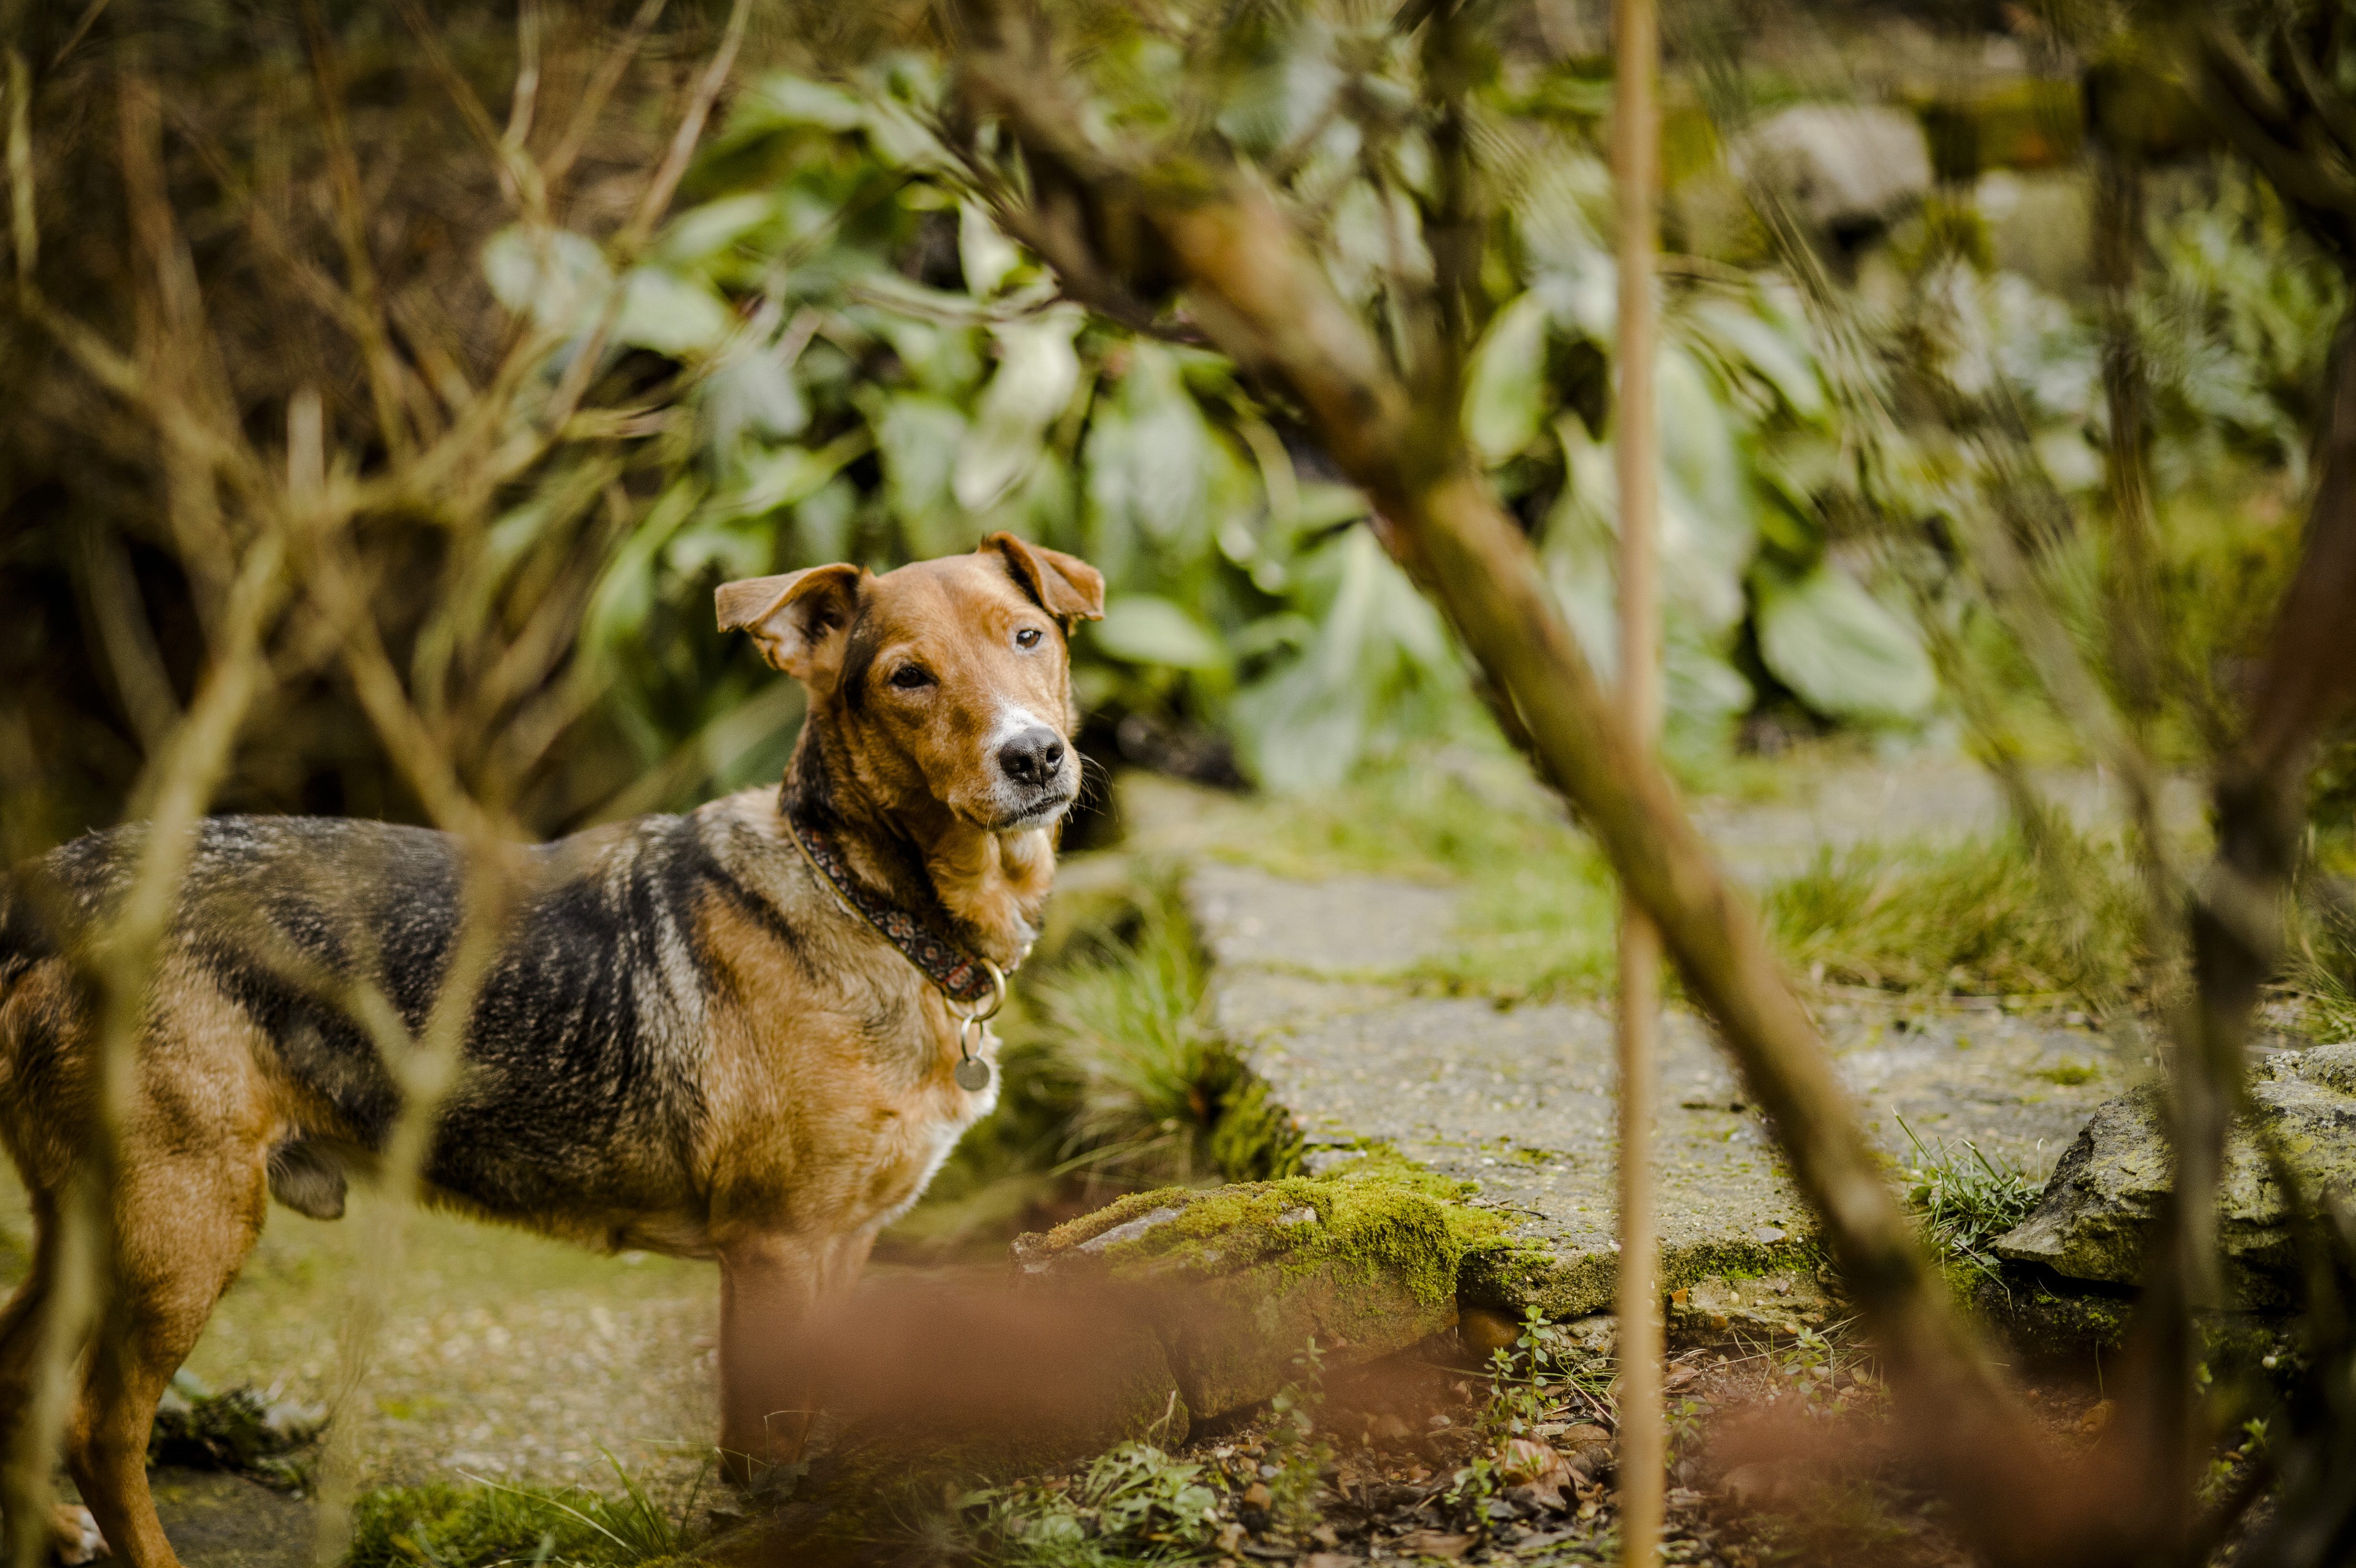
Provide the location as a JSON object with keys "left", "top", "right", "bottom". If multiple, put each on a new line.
{"left": 0, "top": 534, "right": 1105, "bottom": 1568}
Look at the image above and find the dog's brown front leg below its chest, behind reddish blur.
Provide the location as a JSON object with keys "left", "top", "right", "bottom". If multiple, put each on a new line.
{"left": 721, "top": 1234, "right": 874, "bottom": 1486}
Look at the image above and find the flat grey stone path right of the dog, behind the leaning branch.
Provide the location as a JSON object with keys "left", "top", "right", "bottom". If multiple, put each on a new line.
{"left": 1149, "top": 761, "right": 2196, "bottom": 1316}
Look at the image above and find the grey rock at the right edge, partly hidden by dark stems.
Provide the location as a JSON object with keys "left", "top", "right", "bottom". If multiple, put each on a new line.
{"left": 1993, "top": 1045, "right": 2356, "bottom": 1307}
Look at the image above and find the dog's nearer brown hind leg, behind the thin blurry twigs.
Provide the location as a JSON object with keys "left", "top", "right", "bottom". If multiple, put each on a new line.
{"left": 66, "top": 1137, "right": 269, "bottom": 1568}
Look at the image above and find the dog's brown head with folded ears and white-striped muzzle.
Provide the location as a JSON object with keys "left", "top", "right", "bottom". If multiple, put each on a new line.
{"left": 719, "top": 534, "right": 1105, "bottom": 833}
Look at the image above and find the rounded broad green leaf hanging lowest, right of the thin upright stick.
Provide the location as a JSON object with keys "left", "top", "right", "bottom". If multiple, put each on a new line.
{"left": 1753, "top": 563, "right": 1939, "bottom": 723}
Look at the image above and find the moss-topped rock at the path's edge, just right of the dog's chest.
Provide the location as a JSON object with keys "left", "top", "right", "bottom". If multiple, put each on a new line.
{"left": 1013, "top": 1161, "right": 1470, "bottom": 1420}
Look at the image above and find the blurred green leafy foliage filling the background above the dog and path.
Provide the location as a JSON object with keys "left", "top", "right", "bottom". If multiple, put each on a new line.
{"left": 0, "top": 0, "right": 2340, "bottom": 845}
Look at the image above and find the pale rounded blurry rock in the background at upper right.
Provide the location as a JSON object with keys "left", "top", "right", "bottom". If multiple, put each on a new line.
{"left": 1729, "top": 104, "right": 1932, "bottom": 235}
